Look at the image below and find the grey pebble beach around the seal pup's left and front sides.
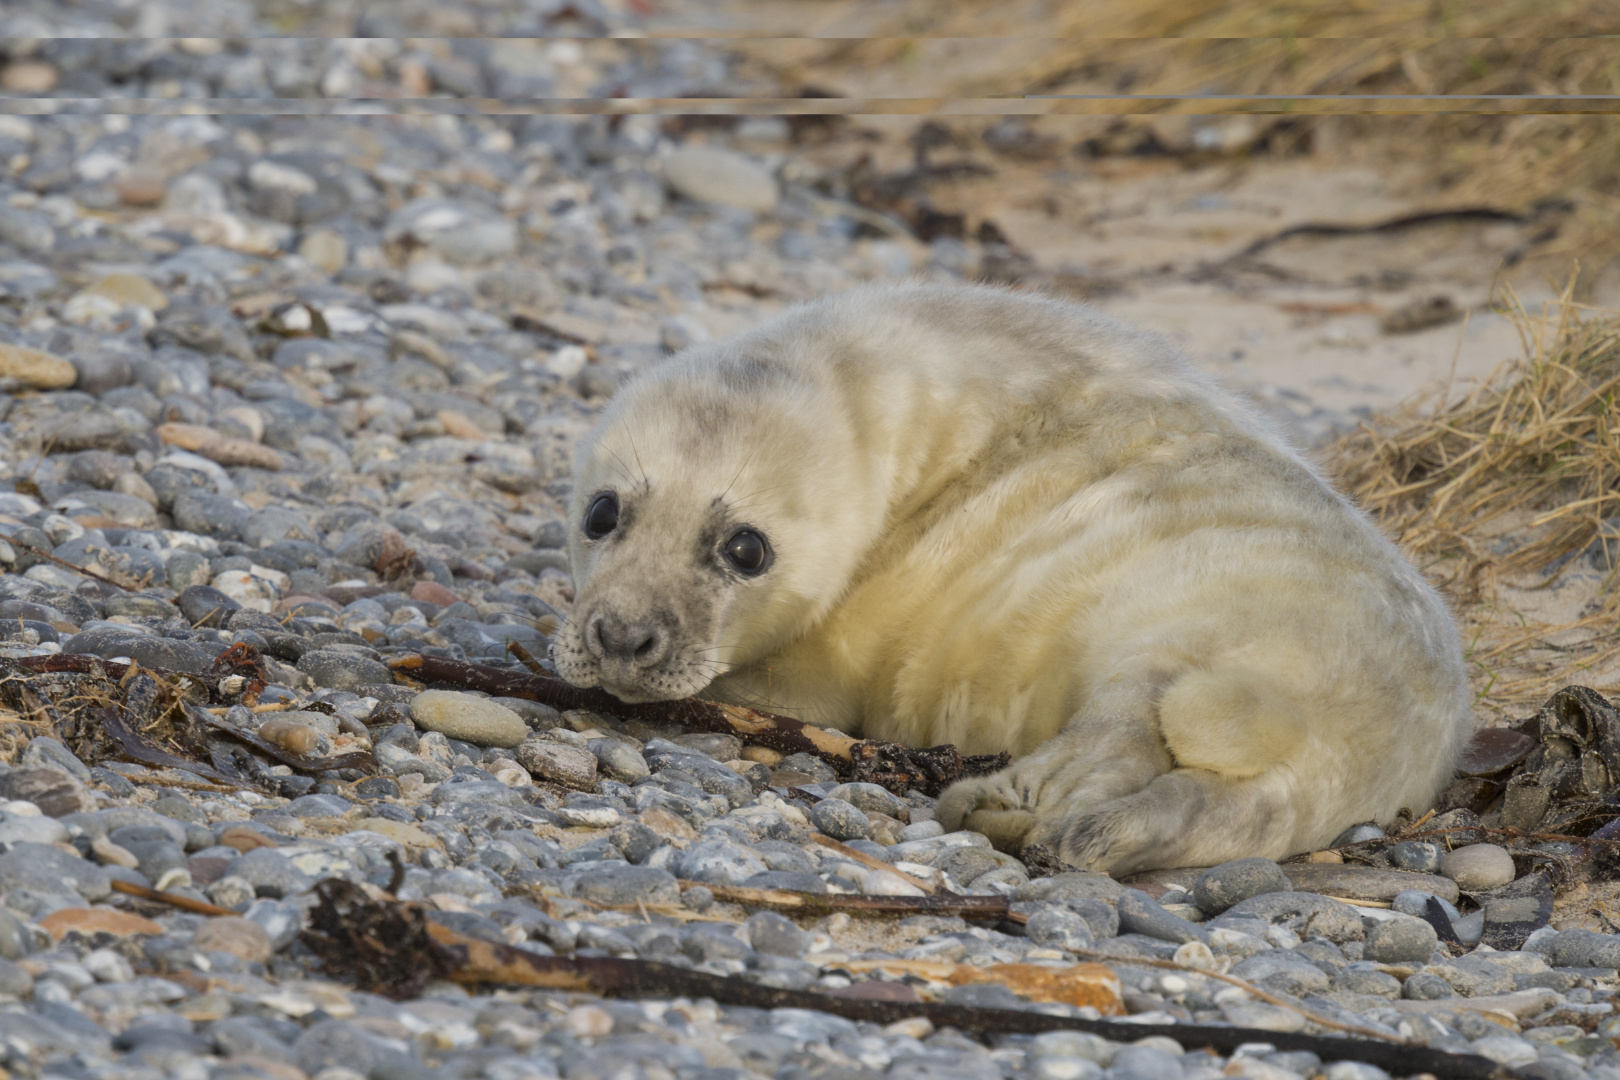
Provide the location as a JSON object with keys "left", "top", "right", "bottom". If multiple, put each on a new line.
{"left": 0, "top": 8, "right": 1620, "bottom": 1080}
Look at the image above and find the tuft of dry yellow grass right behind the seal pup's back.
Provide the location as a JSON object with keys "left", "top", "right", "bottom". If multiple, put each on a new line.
{"left": 1328, "top": 279, "right": 1620, "bottom": 709}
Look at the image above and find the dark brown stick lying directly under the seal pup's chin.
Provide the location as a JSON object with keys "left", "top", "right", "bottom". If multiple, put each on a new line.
{"left": 387, "top": 654, "right": 1008, "bottom": 795}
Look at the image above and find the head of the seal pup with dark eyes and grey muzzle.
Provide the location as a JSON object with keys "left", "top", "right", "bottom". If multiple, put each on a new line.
{"left": 552, "top": 334, "right": 881, "bottom": 701}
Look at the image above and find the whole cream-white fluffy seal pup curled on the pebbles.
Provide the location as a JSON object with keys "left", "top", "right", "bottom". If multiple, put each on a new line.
{"left": 552, "top": 285, "right": 1471, "bottom": 874}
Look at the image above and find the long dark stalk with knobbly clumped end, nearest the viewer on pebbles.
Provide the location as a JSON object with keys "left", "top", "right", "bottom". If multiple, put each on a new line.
{"left": 303, "top": 878, "right": 1497, "bottom": 1080}
